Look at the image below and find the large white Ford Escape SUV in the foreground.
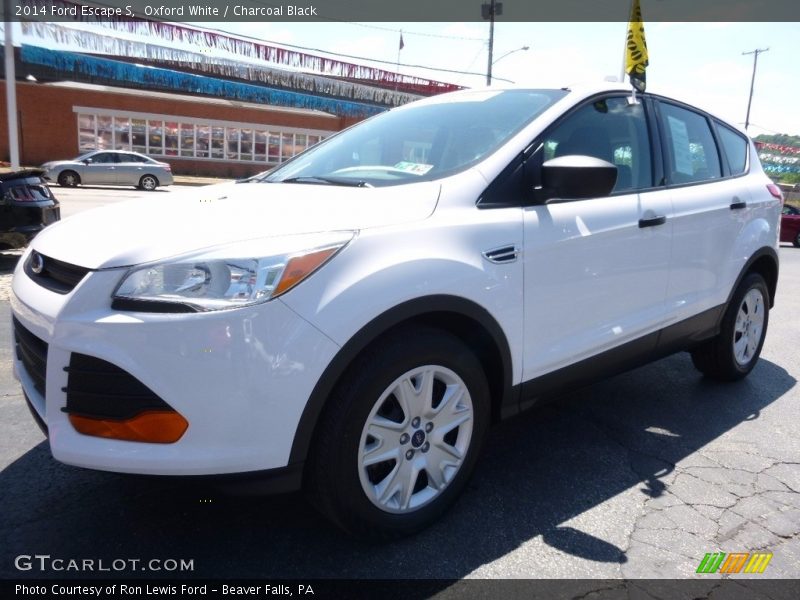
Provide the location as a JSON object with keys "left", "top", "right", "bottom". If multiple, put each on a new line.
{"left": 12, "top": 86, "right": 781, "bottom": 537}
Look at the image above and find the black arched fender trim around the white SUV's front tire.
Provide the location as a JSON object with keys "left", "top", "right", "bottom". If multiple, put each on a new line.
{"left": 289, "top": 295, "right": 519, "bottom": 465}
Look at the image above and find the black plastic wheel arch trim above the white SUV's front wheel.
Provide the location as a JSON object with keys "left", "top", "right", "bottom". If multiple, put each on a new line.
{"left": 289, "top": 295, "right": 518, "bottom": 464}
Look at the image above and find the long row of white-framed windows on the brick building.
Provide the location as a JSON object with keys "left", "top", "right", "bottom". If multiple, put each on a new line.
{"left": 76, "top": 109, "right": 326, "bottom": 164}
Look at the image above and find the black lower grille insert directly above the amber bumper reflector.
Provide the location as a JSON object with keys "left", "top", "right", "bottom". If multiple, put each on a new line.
{"left": 63, "top": 352, "right": 172, "bottom": 420}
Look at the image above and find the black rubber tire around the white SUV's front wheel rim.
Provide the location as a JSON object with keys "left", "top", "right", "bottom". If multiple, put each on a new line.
{"left": 307, "top": 327, "right": 490, "bottom": 540}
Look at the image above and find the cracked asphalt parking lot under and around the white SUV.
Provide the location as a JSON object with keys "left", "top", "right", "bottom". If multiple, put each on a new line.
{"left": 0, "top": 186, "right": 800, "bottom": 579}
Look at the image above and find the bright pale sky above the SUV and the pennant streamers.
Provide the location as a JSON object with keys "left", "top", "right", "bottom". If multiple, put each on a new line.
{"left": 12, "top": 19, "right": 800, "bottom": 136}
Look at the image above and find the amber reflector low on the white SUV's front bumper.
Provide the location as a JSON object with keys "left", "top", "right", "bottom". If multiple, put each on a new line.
{"left": 69, "top": 410, "right": 189, "bottom": 444}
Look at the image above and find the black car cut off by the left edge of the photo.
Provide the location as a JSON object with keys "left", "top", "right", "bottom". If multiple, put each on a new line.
{"left": 0, "top": 169, "right": 61, "bottom": 250}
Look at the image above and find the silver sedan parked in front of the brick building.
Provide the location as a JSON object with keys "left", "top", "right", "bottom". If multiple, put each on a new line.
{"left": 42, "top": 150, "right": 173, "bottom": 191}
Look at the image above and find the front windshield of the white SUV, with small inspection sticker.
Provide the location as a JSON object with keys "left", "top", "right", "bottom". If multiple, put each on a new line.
{"left": 259, "top": 90, "right": 567, "bottom": 186}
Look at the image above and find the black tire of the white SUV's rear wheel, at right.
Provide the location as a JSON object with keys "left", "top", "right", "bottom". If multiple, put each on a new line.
{"left": 692, "top": 273, "right": 770, "bottom": 381}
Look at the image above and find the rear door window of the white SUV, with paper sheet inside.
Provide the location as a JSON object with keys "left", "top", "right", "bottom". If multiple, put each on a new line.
{"left": 661, "top": 102, "right": 722, "bottom": 184}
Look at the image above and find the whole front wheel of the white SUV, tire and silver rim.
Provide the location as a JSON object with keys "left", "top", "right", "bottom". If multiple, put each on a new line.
{"left": 310, "top": 328, "right": 490, "bottom": 539}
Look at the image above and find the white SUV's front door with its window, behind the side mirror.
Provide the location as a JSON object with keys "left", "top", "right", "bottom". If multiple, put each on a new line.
{"left": 523, "top": 96, "right": 672, "bottom": 380}
